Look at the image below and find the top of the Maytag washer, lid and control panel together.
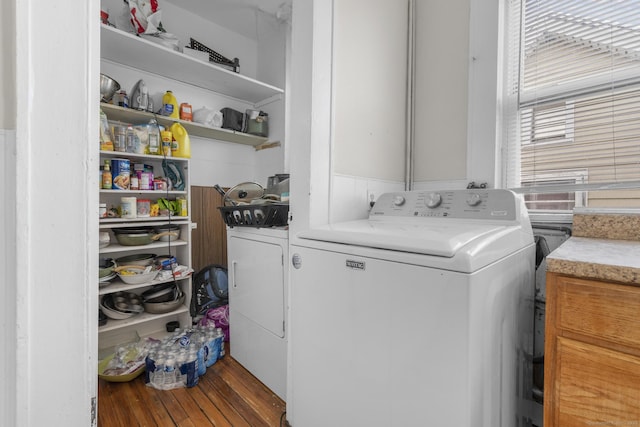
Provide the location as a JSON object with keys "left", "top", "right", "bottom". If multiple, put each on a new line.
{"left": 296, "top": 189, "right": 533, "bottom": 271}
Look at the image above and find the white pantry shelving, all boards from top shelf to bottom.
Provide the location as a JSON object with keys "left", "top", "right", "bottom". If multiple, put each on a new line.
{"left": 96, "top": 20, "right": 284, "bottom": 348}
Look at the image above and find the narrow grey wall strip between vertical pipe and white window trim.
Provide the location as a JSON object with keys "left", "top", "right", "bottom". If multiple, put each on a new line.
{"left": 413, "top": 0, "right": 469, "bottom": 186}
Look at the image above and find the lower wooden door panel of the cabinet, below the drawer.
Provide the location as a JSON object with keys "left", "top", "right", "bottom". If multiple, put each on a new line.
{"left": 545, "top": 337, "right": 640, "bottom": 427}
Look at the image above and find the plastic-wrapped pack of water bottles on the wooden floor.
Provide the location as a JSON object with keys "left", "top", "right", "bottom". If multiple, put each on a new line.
{"left": 145, "top": 326, "right": 225, "bottom": 390}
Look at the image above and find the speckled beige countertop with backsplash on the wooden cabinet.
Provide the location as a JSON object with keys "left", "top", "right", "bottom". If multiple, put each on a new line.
{"left": 547, "top": 214, "right": 640, "bottom": 284}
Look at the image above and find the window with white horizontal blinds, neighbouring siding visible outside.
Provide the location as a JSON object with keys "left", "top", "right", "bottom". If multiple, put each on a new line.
{"left": 503, "top": 0, "right": 640, "bottom": 211}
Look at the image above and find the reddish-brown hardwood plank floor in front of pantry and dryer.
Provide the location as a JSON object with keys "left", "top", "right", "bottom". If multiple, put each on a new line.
{"left": 98, "top": 352, "right": 287, "bottom": 427}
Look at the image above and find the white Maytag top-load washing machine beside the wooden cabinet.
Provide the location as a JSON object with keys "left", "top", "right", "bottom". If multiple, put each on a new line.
{"left": 287, "top": 189, "right": 535, "bottom": 427}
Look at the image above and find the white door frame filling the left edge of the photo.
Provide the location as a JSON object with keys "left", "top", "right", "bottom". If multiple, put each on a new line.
{"left": 5, "top": 0, "right": 99, "bottom": 426}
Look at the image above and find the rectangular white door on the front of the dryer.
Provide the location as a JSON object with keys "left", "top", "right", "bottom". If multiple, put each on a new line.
{"left": 227, "top": 236, "right": 285, "bottom": 337}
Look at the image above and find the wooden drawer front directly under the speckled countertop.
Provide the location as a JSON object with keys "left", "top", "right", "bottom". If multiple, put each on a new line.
{"left": 555, "top": 277, "right": 640, "bottom": 349}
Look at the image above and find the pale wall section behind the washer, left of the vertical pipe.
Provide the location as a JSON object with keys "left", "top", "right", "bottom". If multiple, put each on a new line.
{"left": 329, "top": 0, "right": 409, "bottom": 222}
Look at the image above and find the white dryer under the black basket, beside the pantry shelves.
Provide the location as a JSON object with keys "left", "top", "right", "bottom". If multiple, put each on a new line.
{"left": 227, "top": 227, "right": 289, "bottom": 399}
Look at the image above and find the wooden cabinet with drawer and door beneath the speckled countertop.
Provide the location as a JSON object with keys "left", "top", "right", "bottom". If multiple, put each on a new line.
{"left": 544, "top": 273, "right": 640, "bottom": 427}
